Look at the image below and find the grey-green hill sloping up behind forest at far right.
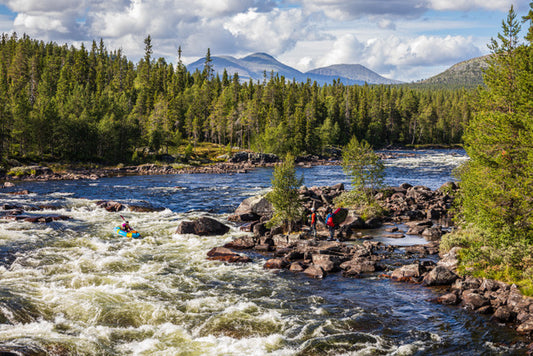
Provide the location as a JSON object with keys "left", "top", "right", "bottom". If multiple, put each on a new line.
{"left": 416, "top": 55, "right": 490, "bottom": 88}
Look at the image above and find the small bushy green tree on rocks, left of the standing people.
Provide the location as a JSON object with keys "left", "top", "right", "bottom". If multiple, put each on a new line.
{"left": 266, "top": 154, "right": 303, "bottom": 232}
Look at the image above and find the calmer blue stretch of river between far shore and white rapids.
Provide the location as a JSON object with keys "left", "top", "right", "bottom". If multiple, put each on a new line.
{"left": 7, "top": 150, "right": 466, "bottom": 214}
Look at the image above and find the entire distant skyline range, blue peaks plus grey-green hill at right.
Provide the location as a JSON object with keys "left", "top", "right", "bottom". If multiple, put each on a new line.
{"left": 187, "top": 53, "right": 488, "bottom": 88}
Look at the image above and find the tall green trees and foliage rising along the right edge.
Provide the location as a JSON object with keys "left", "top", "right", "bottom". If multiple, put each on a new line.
{"left": 441, "top": 2, "right": 533, "bottom": 290}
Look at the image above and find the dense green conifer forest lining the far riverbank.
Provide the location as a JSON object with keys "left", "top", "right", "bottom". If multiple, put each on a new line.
{"left": 0, "top": 34, "right": 471, "bottom": 162}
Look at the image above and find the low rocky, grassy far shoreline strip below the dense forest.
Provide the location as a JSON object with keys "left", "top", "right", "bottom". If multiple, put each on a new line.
{"left": 0, "top": 143, "right": 463, "bottom": 182}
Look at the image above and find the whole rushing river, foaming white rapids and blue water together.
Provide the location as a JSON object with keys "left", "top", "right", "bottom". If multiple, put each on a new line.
{"left": 0, "top": 150, "right": 525, "bottom": 355}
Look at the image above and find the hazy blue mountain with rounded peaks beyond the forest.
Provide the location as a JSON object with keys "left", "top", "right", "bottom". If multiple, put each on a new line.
{"left": 187, "top": 53, "right": 400, "bottom": 85}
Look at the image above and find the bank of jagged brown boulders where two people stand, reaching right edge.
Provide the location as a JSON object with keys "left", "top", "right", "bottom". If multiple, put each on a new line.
{"left": 208, "top": 183, "right": 533, "bottom": 336}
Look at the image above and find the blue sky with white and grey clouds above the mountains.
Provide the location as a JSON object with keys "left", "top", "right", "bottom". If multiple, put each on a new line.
{"left": 0, "top": 0, "right": 529, "bottom": 81}
